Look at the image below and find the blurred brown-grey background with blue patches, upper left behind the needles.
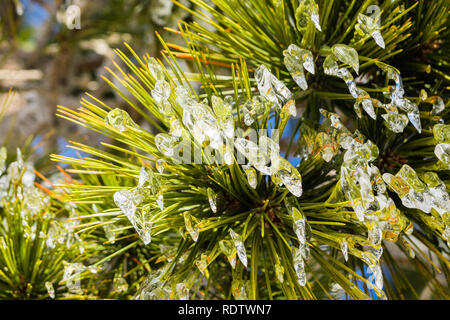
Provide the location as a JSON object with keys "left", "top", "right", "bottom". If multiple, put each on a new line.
{"left": 0, "top": 0, "right": 201, "bottom": 171}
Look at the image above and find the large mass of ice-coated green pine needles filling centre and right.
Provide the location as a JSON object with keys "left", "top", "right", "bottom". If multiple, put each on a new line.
{"left": 1, "top": 0, "right": 450, "bottom": 299}
